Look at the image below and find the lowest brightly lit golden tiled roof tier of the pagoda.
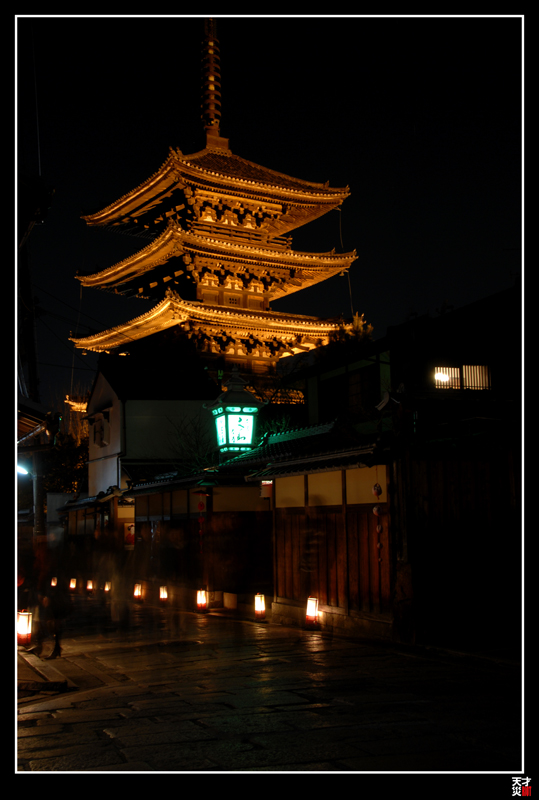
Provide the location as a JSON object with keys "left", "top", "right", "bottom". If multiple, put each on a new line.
{"left": 70, "top": 289, "right": 342, "bottom": 352}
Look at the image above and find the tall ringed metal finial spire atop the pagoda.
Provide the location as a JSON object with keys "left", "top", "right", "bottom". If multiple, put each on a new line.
{"left": 202, "top": 18, "right": 228, "bottom": 150}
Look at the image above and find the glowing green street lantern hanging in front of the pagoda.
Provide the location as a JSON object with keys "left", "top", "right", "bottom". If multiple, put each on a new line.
{"left": 206, "top": 367, "right": 262, "bottom": 458}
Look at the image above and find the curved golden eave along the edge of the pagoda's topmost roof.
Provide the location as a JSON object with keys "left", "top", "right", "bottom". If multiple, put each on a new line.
{"left": 82, "top": 151, "right": 350, "bottom": 225}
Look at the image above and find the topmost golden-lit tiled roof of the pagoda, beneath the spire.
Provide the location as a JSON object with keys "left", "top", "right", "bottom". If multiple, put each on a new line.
{"left": 82, "top": 147, "right": 350, "bottom": 235}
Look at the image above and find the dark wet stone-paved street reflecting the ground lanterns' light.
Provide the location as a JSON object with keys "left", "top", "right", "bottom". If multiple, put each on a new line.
{"left": 16, "top": 601, "right": 524, "bottom": 776}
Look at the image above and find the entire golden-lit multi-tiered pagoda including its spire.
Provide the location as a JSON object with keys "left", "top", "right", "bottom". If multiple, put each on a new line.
{"left": 71, "top": 20, "right": 356, "bottom": 390}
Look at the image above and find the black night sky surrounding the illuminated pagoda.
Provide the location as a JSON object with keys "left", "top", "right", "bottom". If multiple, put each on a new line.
{"left": 15, "top": 16, "right": 523, "bottom": 410}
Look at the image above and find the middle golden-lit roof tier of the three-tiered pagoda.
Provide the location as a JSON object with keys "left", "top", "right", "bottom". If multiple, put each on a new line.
{"left": 77, "top": 222, "right": 356, "bottom": 294}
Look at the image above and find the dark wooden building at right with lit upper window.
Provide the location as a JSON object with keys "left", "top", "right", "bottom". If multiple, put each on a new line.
{"left": 258, "top": 288, "right": 523, "bottom": 655}
